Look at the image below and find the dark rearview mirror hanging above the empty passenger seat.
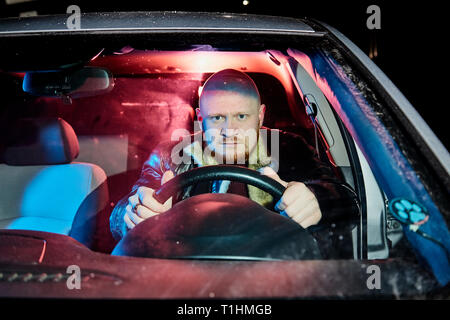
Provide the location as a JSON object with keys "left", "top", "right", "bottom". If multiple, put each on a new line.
{"left": 22, "top": 67, "right": 114, "bottom": 98}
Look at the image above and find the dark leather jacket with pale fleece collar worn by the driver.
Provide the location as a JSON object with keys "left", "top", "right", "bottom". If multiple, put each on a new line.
{"left": 110, "top": 127, "right": 359, "bottom": 240}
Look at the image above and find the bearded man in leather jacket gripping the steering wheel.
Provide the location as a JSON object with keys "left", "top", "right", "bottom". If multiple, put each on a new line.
{"left": 110, "top": 69, "right": 359, "bottom": 248}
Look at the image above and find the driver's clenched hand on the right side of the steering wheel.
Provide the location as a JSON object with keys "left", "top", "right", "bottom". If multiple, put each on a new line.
{"left": 260, "top": 167, "right": 322, "bottom": 228}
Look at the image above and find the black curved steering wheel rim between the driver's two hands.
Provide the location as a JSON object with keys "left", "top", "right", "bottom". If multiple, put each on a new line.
{"left": 153, "top": 165, "right": 286, "bottom": 212}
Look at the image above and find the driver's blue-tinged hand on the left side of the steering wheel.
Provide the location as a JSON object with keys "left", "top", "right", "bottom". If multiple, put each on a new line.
{"left": 123, "top": 170, "right": 174, "bottom": 230}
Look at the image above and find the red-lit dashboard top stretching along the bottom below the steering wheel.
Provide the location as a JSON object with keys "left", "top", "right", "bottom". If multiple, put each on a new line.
{"left": 0, "top": 230, "right": 436, "bottom": 299}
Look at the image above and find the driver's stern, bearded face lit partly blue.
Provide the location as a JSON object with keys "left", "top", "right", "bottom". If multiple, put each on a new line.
{"left": 197, "top": 90, "right": 265, "bottom": 163}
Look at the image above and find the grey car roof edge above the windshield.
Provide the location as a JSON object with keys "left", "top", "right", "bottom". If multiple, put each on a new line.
{"left": 0, "top": 11, "right": 323, "bottom": 35}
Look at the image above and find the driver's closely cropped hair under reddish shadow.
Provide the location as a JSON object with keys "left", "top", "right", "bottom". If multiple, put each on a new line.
{"left": 199, "top": 69, "right": 261, "bottom": 104}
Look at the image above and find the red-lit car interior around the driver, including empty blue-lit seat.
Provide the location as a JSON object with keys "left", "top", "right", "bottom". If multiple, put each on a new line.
{"left": 0, "top": 47, "right": 394, "bottom": 259}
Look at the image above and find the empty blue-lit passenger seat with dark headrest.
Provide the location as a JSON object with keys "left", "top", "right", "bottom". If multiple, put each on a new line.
{"left": 0, "top": 118, "right": 109, "bottom": 247}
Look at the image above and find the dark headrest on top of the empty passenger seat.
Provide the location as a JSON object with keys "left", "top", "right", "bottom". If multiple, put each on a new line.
{"left": 2, "top": 118, "right": 80, "bottom": 166}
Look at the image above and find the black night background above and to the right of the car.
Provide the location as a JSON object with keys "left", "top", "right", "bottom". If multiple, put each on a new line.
{"left": 0, "top": 0, "right": 450, "bottom": 149}
